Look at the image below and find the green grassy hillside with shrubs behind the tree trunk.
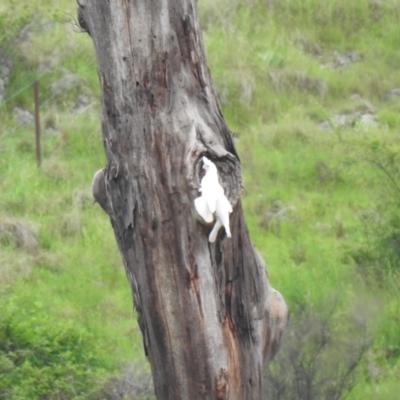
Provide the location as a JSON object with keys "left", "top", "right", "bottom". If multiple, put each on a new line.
{"left": 0, "top": 0, "right": 400, "bottom": 400}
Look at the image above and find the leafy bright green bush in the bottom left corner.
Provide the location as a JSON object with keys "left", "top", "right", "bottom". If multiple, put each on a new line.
{"left": 0, "top": 306, "right": 109, "bottom": 400}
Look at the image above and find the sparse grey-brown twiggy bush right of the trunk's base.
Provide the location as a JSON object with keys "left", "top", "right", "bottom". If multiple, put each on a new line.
{"left": 264, "top": 305, "right": 370, "bottom": 400}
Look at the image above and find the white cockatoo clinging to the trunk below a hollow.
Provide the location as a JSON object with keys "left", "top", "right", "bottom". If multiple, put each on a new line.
{"left": 194, "top": 157, "right": 232, "bottom": 243}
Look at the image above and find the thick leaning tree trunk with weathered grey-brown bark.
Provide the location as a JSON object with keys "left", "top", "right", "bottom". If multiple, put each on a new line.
{"left": 78, "top": 0, "right": 288, "bottom": 400}
